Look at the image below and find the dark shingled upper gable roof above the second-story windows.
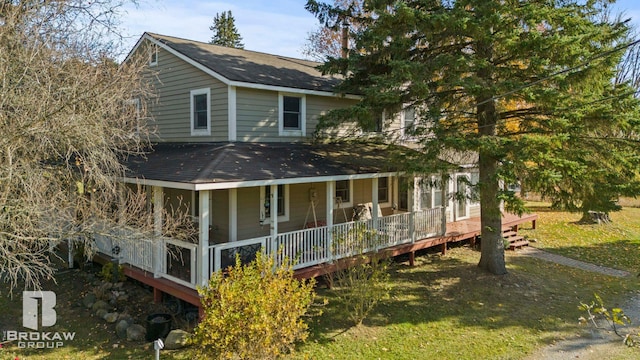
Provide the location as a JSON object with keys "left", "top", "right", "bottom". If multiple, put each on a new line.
{"left": 146, "top": 33, "right": 340, "bottom": 92}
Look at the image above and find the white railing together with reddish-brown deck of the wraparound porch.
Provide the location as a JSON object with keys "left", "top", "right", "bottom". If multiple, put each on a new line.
{"left": 92, "top": 208, "right": 537, "bottom": 306}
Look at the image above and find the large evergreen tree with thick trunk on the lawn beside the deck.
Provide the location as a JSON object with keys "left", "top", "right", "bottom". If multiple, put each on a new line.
{"left": 306, "top": 0, "right": 639, "bottom": 274}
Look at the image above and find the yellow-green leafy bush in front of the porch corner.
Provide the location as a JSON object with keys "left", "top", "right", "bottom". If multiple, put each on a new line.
{"left": 192, "top": 253, "right": 314, "bottom": 359}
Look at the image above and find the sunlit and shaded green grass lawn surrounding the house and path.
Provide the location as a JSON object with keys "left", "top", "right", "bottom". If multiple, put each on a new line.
{"left": 0, "top": 207, "right": 640, "bottom": 360}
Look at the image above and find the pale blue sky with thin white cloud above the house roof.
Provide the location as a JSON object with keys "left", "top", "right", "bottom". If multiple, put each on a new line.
{"left": 122, "top": 0, "right": 640, "bottom": 58}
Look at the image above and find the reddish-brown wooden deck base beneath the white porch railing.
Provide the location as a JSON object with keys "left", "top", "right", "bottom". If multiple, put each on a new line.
{"left": 96, "top": 214, "right": 538, "bottom": 313}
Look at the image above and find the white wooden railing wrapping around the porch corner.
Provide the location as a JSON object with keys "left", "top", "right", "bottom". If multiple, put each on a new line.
{"left": 95, "top": 208, "right": 443, "bottom": 288}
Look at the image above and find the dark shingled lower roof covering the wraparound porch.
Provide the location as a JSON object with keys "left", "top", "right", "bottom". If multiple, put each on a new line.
{"left": 125, "top": 142, "right": 410, "bottom": 185}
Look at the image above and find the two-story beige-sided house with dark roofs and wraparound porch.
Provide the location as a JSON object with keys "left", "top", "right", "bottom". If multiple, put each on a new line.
{"left": 97, "top": 33, "right": 536, "bottom": 310}
